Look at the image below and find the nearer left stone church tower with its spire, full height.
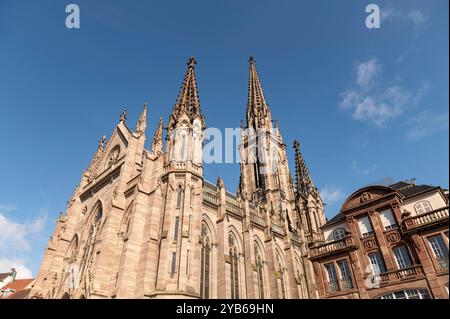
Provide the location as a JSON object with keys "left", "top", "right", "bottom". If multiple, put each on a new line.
{"left": 154, "top": 58, "right": 205, "bottom": 298}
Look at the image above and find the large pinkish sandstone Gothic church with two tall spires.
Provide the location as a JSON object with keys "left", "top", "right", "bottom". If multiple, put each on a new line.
{"left": 30, "top": 58, "right": 326, "bottom": 299}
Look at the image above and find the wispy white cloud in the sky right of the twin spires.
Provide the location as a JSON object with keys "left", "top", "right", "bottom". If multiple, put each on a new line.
{"left": 339, "top": 58, "right": 430, "bottom": 127}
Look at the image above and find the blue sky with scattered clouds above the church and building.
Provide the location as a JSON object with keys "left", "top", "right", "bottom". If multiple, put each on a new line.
{"left": 0, "top": 0, "right": 449, "bottom": 276}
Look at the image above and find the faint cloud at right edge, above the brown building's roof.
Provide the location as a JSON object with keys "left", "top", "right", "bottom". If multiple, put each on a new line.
{"left": 406, "top": 111, "right": 449, "bottom": 140}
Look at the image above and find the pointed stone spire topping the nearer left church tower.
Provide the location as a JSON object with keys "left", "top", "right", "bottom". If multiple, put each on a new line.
{"left": 172, "top": 57, "right": 201, "bottom": 119}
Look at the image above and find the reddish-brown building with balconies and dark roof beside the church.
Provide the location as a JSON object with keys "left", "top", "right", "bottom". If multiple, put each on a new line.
{"left": 311, "top": 182, "right": 449, "bottom": 299}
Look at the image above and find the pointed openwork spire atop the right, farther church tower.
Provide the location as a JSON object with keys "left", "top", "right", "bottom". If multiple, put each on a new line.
{"left": 247, "top": 56, "right": 272, "bottom": 129}
